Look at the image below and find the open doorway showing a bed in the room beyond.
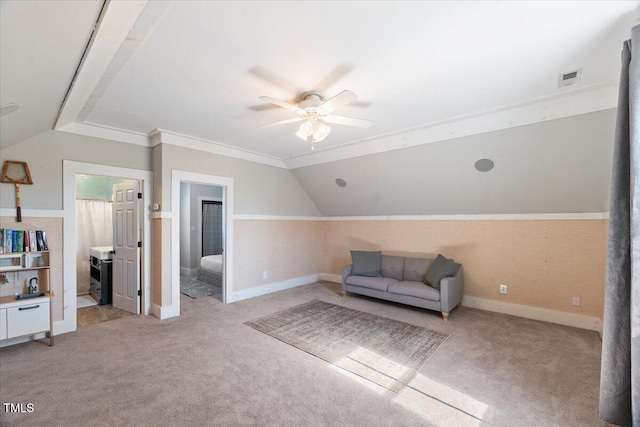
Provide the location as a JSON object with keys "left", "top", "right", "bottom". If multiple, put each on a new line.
{"left": 180, "top": 182, "right": 225, "bottom": 302}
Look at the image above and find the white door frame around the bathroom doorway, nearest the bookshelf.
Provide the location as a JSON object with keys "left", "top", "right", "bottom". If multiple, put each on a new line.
{"left": 62, "top": 160, "right": 153, "bottom": 335}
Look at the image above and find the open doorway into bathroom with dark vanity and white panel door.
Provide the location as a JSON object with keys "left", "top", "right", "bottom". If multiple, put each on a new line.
{"left": 75, "top": 174, "right": 143, "bottom": 328}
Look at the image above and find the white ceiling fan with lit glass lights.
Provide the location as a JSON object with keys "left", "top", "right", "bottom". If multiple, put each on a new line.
{"left": 259, "top": 90, "right": 371, "bottom": 150}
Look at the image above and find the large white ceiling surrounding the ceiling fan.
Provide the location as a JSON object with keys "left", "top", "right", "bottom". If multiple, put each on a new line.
{"left": 0, "top": 0, "right": 639, "bottom": 168}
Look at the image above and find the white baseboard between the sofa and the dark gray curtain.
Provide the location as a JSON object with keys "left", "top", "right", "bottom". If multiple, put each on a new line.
{"left": 462, "top": 295, "right": 602, "bottom": 335}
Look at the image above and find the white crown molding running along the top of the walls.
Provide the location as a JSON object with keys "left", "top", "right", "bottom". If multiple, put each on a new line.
{"left": 58, "top": 81, "right": 618, "bottom": 169}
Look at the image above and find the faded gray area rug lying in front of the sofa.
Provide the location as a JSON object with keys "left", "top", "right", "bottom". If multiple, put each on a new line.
{"left": 245, "top": 299, "right": 449, "bottom": 392}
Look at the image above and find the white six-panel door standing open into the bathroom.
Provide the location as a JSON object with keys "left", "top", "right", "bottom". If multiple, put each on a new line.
{"left": 112, "top": 181, "right": 141, "bottom": 314}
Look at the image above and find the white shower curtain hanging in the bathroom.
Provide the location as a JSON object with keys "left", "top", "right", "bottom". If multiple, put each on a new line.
{"left": 76, "top": 199, "right": 113, "bottom": 295}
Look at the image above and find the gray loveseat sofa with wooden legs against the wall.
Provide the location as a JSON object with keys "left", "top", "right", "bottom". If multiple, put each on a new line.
{"left": 342, "top": 252, "right": 463, "bottom": 322}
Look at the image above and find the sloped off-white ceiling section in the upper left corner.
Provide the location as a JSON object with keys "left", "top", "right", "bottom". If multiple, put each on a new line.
{"left": 0, "top": 0, "right": 103, "bottom": 148}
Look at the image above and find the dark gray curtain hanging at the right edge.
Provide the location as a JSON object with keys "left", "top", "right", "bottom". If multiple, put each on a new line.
{"left": 600, "top": 26, "right": 640, "bottom": 427}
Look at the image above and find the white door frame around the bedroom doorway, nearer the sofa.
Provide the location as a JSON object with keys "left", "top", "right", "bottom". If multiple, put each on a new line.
{"left": 171, "top": 169, "right": 233, "bottom": 313}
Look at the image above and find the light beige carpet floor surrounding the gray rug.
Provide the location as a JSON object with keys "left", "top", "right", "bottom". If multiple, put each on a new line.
{"left": 0, "top": 282, "right": 604, "bottom": 427}
